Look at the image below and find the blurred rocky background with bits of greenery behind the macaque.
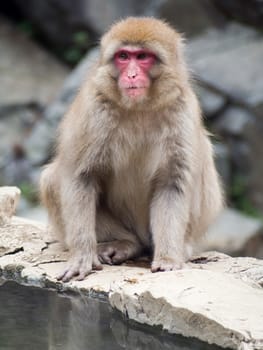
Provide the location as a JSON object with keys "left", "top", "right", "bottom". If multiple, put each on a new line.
{"left": 0, "top": 0, "right": 263, "bottom": 258}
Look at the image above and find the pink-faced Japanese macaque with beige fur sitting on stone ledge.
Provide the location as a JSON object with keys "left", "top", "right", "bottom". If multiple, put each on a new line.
{"left": 41, "top": 18, "right": 222, "bottom": 281}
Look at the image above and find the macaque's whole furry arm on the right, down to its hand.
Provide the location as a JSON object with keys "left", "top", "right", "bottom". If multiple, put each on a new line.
{"left": 150, "top": 127, "right": 194, "bottom": 272}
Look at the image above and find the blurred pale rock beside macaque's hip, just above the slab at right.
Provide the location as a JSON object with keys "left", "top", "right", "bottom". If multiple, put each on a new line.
{"left": 203, "top": 208, "right": 263, "bottom": 258}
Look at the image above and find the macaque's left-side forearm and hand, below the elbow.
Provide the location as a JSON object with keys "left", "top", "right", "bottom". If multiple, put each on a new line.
{"left": 58, "top": 177, "right": 102, "bottom": 282}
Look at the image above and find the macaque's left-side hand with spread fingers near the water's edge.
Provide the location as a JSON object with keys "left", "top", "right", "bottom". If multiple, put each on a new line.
{"left": 57, "top": 251, "right": 102, "bottom": 282}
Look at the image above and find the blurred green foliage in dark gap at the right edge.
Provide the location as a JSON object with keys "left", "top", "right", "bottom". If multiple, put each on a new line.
{"left": 229, "top": 175, "right": 262, "bottom": 218}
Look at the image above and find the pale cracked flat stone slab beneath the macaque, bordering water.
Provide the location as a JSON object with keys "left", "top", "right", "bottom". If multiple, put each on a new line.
{"left": 0, "top": 217, "right": 263, "bottom": 350}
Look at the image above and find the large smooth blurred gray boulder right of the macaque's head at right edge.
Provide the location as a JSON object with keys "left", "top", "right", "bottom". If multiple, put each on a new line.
{"left": 188, "top": 24, "right": 263, "bottom": 115}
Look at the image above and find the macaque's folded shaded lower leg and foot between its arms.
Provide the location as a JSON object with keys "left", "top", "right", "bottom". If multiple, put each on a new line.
{"left": 96, "top": 211, "right": 143, "bottom": 265}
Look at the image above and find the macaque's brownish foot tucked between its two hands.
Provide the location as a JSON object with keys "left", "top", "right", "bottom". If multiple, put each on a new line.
{"left": 97, "top": 240, "right": 141, "bottom": 265}
